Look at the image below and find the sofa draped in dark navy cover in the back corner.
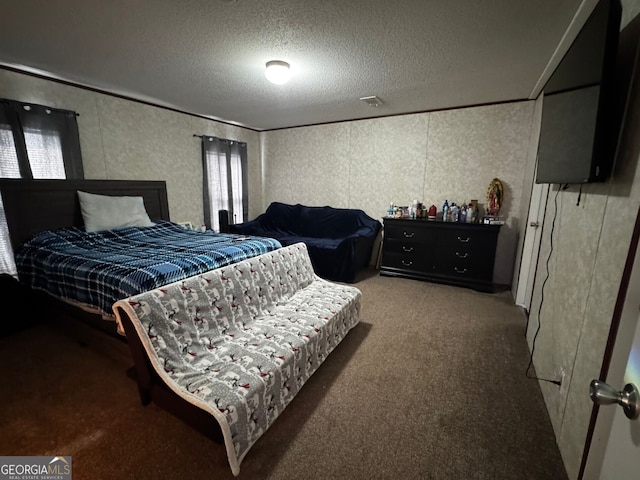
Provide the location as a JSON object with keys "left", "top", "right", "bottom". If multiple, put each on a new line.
{"left": 228, "top": 202, "right": 382, "bottom": 283}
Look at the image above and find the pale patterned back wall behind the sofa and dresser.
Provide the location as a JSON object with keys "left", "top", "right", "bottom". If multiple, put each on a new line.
{"left": 261, "top": 102, "right": 536, "bottom": 285}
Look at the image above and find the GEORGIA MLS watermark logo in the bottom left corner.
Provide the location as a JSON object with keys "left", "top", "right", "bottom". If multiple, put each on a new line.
{"left": 0, "top": 456, "right": 71, "bottom": 480}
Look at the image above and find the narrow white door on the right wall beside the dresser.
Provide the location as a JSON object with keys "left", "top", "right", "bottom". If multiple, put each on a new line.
{"left": 515, "top": 183, "right": 549, "bottom": 312}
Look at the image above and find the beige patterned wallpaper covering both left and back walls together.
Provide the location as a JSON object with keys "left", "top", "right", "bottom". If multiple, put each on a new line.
{"left": 0, "top": 70, "right": 534, "bottom": 285}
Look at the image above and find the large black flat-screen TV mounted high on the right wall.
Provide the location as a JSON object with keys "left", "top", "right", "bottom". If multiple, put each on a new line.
{"left": 536, "top": 0, "right": 622, "bottom": 184}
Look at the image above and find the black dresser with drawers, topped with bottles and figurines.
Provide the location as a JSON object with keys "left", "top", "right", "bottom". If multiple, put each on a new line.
{"left": 380, "top": 218, "right": 500, "bottom": 292}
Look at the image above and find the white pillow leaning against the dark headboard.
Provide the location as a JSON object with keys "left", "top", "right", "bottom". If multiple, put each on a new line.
{"left": 78, "top": 190, "right": 155, "bottom": 232}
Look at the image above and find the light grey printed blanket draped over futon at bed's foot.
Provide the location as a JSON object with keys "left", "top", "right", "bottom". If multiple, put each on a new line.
{"left": 114, "top": 243, "right": 361, "bottom": 475}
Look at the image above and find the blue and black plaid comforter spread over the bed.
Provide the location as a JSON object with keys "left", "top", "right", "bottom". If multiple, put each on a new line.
{"left": 15, "top": 221, "right": 282, "bottom": 317}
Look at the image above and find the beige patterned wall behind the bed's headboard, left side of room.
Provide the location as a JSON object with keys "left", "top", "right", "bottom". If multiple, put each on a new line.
{"left": 0, "top": 69, "right": 262, "bottom": 225}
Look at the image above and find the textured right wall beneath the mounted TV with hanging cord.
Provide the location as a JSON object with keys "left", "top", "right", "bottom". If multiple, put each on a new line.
{"left": 527, "top": 0, "right": 640, "bottom": 479}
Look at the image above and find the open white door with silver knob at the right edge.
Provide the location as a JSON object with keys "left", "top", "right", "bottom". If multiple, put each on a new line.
{"left": 582, "top": 210, "right": 640, "bottom": 480}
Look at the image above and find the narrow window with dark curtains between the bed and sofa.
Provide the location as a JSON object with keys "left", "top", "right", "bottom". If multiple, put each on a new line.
{"left": 202, "top": 136, "right": 248, "bottom": 231}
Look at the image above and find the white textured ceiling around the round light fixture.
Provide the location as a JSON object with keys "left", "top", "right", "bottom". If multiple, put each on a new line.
{"left": 0, "top": 0, "right": 595, "bottom": 130}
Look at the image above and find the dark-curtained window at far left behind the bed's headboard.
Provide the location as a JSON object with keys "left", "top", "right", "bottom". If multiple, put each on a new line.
{"left": 0, "top": 99, "right": 84, "bottom": 276}
